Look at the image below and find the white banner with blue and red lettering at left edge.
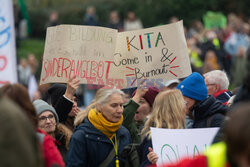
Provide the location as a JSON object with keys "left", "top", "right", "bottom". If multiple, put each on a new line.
{"left": 0, "top": 0, "right": 17, "bottom": 86}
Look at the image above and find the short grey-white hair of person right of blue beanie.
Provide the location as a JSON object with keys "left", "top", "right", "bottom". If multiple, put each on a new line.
{"left": 203, "top": 70, "right": 229, "bottom": 90}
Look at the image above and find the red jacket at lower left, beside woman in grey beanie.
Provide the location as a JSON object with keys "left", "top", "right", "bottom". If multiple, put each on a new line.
{"left": 37, "top": 129, "right": 65, "bottom": 167}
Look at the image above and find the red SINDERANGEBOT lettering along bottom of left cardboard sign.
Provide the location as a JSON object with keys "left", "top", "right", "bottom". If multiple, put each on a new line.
{"left": 42, "top": 57, "right": 117, "bottom": 87}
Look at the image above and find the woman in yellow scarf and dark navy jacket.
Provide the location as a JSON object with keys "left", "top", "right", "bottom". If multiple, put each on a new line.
{"left": 67, "top": 89, "right": 131, "bottom": 167}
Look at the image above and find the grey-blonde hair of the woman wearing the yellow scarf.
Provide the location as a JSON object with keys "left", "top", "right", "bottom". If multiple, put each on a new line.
{"left": 74, "top": 88, "right": 124, "bottom": 126}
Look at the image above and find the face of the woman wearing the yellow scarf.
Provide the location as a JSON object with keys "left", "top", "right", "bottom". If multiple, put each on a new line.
{"left": 98, "top": 94, "right": 124, "bottom": 123}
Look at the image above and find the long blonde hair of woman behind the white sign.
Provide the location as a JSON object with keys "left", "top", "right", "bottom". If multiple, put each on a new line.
{"left": 141, "top": 89, "right": 185, "bottom": 140}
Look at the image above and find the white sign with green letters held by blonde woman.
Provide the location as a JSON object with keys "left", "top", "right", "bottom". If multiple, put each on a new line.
{"left": 150, "top": 128, "right": 219, "bottom": 165}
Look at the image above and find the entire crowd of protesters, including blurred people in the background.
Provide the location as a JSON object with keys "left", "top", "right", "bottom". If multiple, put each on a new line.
{"left": 0, "top": 4, "right": 250, "bottom": 167}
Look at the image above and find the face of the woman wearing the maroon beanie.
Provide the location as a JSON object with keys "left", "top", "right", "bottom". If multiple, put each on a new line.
{"left": 134, "top": 97, "right": 151, "bottom": 121}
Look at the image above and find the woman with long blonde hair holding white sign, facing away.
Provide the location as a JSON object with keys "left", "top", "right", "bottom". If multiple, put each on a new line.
{"left": 141, "top": 89, "right": 186, "bottom": 167}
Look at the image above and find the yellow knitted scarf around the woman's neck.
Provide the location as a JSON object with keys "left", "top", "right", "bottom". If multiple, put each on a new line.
{"left": 88, "top": 108, "right": 123, "bottom": 140}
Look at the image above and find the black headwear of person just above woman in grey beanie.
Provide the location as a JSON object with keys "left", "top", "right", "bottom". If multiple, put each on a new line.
{"left": 48, "top": 84, "right": 66, "bottom": 106}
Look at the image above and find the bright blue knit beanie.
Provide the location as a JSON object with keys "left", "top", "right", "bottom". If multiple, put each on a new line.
{"left": 177, "top": 72, "right": 207, "bottom": 101}
